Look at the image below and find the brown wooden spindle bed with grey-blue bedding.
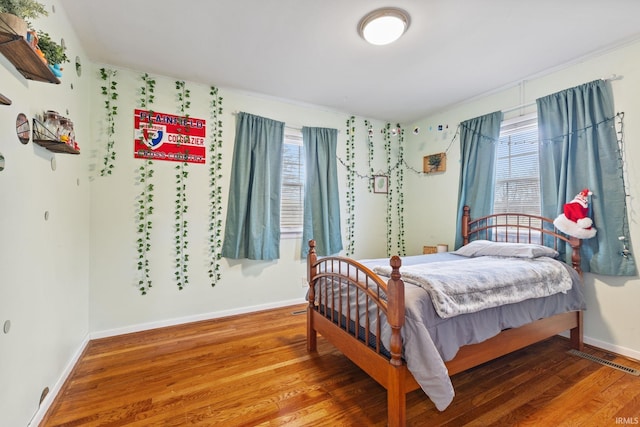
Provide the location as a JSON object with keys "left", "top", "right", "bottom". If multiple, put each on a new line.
{"left": 307, "top": 206, "right": 585, "bottom": 426}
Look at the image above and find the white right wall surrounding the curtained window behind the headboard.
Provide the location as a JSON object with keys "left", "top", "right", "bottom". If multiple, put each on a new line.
{"left": 406, "top": 42, "right": 640, "bottom": 359}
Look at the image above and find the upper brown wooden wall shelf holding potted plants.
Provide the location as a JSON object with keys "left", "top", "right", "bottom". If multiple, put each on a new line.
{"left": 0, "top": 30, "right": 60, "bottom": 84}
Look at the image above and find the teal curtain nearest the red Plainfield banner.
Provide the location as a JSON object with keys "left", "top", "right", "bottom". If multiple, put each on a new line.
{"left": 222, "top": 112, "right": 284, "bottom": 260}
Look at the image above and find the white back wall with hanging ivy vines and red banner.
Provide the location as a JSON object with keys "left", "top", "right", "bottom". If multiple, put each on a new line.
{"left": 89, "top": 66, "right": 392, "bottom": 335}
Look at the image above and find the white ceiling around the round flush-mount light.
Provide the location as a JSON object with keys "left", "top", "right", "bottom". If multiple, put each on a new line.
{"left": 61, "top": 0, "right": 640, "bottom": 124}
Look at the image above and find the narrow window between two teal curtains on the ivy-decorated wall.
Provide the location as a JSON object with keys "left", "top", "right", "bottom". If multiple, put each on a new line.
{"left": 280, "top": 129, "right": 305, "bottom": 234}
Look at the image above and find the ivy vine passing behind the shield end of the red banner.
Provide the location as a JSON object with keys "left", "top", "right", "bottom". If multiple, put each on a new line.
{"left": 136, "top": 73, "right": 156, "bottom": 295}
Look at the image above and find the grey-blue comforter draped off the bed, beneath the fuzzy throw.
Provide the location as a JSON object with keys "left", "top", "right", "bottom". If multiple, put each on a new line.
{"left": 352, "top": 253, "right": 586, "bottom": 410}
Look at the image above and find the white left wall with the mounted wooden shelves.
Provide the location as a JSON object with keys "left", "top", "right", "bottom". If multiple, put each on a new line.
{"left": 0, "top": 2, "right": 93, "bottom": 426}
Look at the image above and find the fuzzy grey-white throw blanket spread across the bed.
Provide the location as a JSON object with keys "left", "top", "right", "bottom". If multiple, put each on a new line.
{"left": 373, "top": 256, "right": 571, "bottom": 318}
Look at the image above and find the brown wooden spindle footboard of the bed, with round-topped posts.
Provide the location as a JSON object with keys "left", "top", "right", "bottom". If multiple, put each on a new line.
{"left": 307, "top": 240, "right": 419, "bottom": 426}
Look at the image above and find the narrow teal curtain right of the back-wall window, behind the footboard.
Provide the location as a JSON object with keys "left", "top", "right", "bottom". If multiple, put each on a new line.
{"left": 302, "top": 127, "right": 342, "bottom": 257}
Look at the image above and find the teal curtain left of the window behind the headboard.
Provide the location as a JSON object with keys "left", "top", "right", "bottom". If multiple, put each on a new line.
{"left": 455, "top": 111, "right": 502, "bottom": 249}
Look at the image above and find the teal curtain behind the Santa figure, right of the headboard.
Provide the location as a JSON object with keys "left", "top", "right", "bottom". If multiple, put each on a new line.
{"left": 537, "top": 80, "right": 636, "bottom": 276}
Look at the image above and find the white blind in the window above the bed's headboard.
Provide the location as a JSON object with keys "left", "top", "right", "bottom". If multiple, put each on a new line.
{"left": 493, "top": 115, "right": 540, "bottom": 215}
